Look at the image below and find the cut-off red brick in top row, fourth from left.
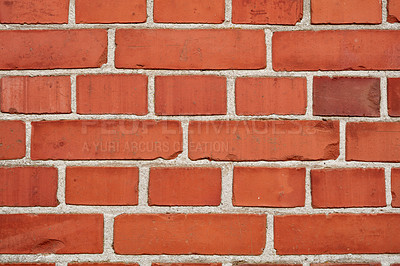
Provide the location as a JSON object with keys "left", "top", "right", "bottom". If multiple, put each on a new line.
{"left": 232, "top": 0, "right": 303, "bottom": 25}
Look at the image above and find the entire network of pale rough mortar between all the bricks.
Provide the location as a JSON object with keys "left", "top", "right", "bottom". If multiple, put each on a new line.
{"left": 0, "top": 0, "right": 400, "bottom": 266}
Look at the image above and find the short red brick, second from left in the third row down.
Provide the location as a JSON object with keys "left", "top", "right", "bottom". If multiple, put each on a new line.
{"left": 76, "top": 75, "right": 148, "bottom": 115}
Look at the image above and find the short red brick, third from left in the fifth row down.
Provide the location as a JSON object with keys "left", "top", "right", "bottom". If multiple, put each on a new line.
{"left": 149, "top": 168, "right": 221, "bottom": 206}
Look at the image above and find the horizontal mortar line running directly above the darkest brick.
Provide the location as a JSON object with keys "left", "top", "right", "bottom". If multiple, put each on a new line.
{"left": 0, "top": 66, "right": 400, "bottom": 78}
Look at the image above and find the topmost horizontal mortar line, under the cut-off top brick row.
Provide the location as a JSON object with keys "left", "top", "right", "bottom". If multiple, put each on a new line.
{"left": 0, "top": 22, "right": 400, "bottom": 31}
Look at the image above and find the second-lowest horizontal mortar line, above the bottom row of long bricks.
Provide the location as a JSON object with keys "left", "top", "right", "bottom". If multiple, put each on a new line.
{"left": 0, "top": 205, "right": 400, "bottom": 214}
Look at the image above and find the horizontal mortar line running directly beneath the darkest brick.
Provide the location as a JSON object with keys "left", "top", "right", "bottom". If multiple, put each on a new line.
{"left": 0, "top": 113, "right": 400, "bottom": 121}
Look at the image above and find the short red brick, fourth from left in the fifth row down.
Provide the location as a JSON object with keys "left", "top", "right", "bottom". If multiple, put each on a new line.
{"left": 233, "top": 167, "right": 306, "bottom": 207}
